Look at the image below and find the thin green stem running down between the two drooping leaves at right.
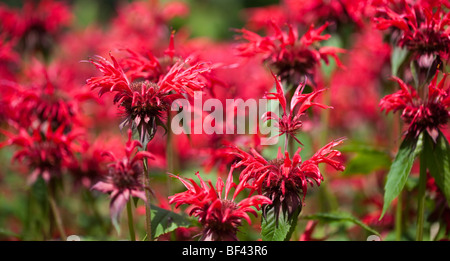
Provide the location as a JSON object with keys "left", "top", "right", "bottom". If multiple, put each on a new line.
{"left": 416, "top": 153, "right": 427, "bottom": 241}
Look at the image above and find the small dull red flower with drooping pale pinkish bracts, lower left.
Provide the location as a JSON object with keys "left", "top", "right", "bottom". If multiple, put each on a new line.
{"left": 92, "top": 130, "right": 153, "bottom": 224}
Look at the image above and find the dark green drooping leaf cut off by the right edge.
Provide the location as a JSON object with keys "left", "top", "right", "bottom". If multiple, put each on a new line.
{"left": 423, "top": 131, "right": 450, "bottom": 204}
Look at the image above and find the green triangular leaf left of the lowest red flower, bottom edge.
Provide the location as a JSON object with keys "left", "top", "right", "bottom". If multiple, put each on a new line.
{"left": 151, "top": 205, "right": 192, "bottom": 238}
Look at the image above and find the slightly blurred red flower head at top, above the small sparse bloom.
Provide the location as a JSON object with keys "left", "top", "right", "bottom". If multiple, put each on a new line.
{"left": 237, "top": 22, "right": 344, "bottom": 82}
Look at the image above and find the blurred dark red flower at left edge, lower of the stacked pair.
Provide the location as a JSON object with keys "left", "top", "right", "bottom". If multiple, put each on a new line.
{"left": 0, "top": 123, "right": 83, "bottom": 184}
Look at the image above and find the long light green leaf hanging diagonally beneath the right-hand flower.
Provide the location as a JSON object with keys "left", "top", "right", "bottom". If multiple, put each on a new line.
{"left": 380, "top": 133, "right": 423, "bottom": 219}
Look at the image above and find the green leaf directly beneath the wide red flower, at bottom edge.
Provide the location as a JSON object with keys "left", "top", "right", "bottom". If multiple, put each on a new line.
{"left": 261, "top": 208, "right": 300, "bottom": 241}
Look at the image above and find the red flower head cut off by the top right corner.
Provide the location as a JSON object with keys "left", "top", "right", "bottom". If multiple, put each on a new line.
{"left": 374, "top": 0, "right": 450, "bottom": 61}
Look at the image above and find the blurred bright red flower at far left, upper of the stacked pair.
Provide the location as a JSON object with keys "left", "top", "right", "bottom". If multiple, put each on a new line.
{"left": 3, "top": 60, "right": 94, "bottom": 128}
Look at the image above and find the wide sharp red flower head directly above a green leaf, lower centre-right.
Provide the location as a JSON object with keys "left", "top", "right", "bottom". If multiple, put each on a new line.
{"left": 234, "top": 139, "right": 344, "bottom": 220}
